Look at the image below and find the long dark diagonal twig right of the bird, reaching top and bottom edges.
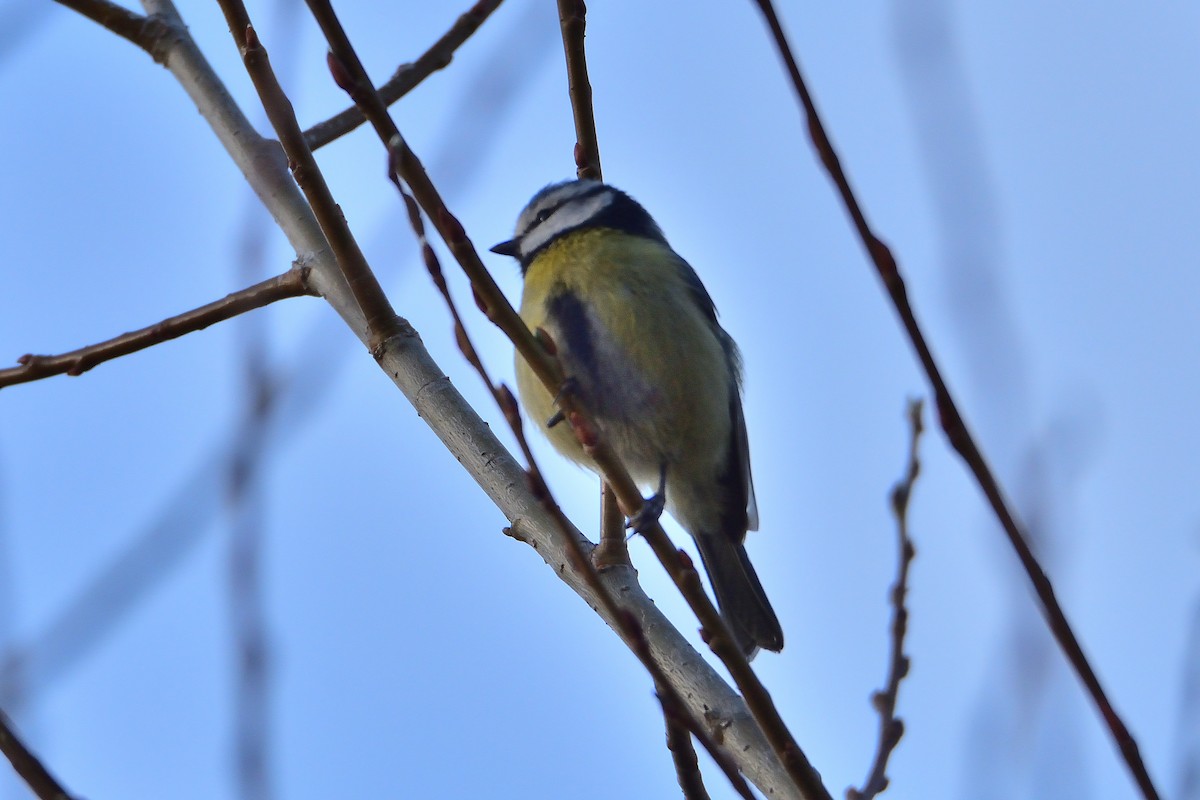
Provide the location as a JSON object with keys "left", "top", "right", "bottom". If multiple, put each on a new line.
{"left": 755, "top": 6, "right": 1159, "bottom": 800}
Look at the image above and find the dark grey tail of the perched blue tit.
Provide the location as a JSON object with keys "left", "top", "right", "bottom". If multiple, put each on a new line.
{"left": 696, "top": 534, "right": 784, "bottom": 658}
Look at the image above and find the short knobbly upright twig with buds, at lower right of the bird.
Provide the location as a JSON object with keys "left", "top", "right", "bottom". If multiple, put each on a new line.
{"left": 846, "top": 399, "right": 925, "bottom": 800}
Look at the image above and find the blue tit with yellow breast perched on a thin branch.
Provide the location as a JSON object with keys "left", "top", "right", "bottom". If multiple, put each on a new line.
{"left": 492, "top": 180, "right": 784, "bottom": 656}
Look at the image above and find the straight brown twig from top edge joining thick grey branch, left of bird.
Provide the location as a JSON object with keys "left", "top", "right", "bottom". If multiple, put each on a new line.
{"left": 218, "top": 6, "right": 396, "bottom": 350}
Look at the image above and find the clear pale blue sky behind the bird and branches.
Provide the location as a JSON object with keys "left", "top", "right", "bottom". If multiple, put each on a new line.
{"left": 0, "top": 0, "right": 1200, "bottom": 800}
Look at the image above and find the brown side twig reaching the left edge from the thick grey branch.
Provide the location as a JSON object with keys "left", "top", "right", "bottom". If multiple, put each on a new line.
{"left": 0, "top": 267, "right": 314, "bottom": 389}
